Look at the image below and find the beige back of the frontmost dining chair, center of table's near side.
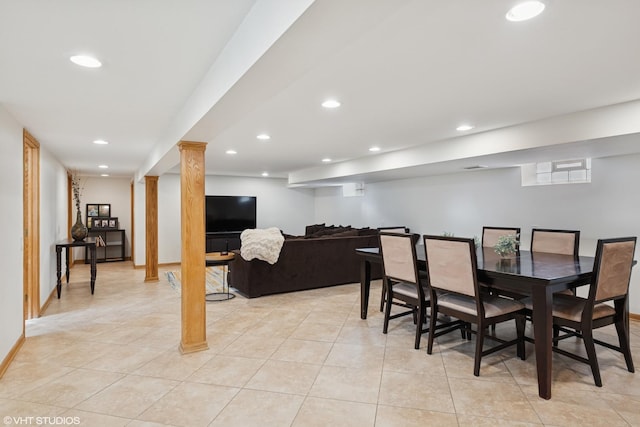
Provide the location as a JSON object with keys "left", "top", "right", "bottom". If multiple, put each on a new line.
{"left": 424, "top": 236, "right": 478, "bottom": 298}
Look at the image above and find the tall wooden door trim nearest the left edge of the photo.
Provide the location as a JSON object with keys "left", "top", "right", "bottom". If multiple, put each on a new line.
{"left": 22, "top": 129, "right": 40, "bottom": 320}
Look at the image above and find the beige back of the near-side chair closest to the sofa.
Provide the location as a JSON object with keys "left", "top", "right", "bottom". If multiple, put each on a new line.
{"left": 380, "top": 232, "right": 419, "bottom": 284}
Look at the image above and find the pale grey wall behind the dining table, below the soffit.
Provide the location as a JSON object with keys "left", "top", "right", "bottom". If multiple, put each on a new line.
{"left": 315, "top": 152, "right": 640, "bottom": 313}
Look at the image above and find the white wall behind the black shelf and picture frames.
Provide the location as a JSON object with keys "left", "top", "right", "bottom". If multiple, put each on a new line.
{"left": 79, "top": 177, "right": 131, "bottom": 259}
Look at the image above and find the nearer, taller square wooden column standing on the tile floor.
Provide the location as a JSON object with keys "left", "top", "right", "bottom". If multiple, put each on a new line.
{"left": 178, "top": 141, "right": 209, "bottom": 353}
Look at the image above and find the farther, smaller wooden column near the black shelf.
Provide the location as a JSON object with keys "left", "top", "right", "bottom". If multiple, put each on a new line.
{"left": 144, "top": 176, "right": 159, "bottom": 282}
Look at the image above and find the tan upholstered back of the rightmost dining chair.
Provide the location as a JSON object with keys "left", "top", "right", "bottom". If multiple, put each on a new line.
{"left": 589, "top": 237, "right": 636, "bottom": 302}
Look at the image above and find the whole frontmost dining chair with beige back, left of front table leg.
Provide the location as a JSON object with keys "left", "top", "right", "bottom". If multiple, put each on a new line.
{"left": 424, "top": 236, "right": 525, "bottom": 376}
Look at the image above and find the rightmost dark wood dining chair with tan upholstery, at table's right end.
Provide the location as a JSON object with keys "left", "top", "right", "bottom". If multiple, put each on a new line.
{"left": 524, "top": 237, "right": 636, "bottom": 387}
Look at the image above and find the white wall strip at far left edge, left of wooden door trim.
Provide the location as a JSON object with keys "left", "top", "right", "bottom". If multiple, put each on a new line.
{"left": 0, "top": 105, "right": 23, "bottom": 361}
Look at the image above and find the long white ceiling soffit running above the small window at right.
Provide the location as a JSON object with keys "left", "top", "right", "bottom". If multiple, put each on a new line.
{"left": 289, "top": 101, "right": 640, "bottom": 185}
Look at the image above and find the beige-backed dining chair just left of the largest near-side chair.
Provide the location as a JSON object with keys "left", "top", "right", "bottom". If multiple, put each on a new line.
{"left": 380, "top": 231, "right": 429, "bottom": 350}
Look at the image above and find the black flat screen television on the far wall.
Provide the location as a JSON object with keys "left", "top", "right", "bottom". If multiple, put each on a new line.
{"left": 205, "top": 196, "right": 256, "bottom": 233}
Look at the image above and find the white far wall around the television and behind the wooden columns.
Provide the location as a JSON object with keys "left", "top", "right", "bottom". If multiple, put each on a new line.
{"left": 152, "top": 174, "right": 314, "bottom": 265}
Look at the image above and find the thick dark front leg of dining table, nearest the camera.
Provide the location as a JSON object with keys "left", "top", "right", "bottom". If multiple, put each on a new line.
{"left": 531, "top": 286, "right": 553, "bottom": 399}
